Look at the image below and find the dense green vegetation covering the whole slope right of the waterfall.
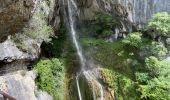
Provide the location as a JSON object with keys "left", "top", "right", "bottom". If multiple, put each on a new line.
{"left": 82, "top": 12, "right": 170, "bottom": 100}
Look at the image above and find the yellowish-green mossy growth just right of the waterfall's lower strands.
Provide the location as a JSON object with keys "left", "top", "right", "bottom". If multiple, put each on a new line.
{"left": 101, "top": 69, "right": 137, "bottom": 100}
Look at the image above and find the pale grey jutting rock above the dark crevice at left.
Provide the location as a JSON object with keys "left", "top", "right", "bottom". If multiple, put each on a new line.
{"left": 0, "top": 39, "right": 40, "bottom": 62}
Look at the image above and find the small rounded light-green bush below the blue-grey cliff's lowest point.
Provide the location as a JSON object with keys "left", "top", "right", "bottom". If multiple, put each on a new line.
{"left": 122, "top": 32, "right": 142, "bottom": 47}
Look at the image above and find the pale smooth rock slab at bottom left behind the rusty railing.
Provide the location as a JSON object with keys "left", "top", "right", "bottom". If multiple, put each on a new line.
{"left": 0, "top": 71, "right": 52, "bottom": 100}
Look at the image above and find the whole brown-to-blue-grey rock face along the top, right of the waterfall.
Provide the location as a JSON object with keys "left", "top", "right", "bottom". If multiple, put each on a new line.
{"left": 63, "top": 0, "right": 170, "bottom": 27}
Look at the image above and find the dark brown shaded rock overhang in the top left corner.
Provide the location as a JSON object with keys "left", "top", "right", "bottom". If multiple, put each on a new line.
{"left": 0, "top": 0, "right": 34, "bottom": 41}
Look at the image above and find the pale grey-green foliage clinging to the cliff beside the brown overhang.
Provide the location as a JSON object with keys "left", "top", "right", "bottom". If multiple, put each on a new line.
{"left": 24, "top": 14, "right": 54, "bottom": 42}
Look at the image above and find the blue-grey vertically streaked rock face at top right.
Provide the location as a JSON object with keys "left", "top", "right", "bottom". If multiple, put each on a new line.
{"left": 113, "top": 0, "right": 170, "bottom": 25}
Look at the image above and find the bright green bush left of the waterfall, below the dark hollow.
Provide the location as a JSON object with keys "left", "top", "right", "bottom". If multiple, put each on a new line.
{"left": 35, "top": 58, "right": 64, "bottom": 100}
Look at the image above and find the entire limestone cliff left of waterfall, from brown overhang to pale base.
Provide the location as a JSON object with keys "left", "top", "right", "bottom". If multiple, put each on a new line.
{"left": 0, "top": 0, "right": 54, "bottom": 100}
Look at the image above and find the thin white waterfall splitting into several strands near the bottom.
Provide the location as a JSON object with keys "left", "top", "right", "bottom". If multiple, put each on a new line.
{"left": 67, "top": 0, "right": 104, "bottom": 100}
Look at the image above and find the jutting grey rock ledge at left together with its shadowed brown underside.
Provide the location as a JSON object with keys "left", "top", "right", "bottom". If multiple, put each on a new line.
{"left": 0, "top": 38, "right": 40, "bottom": 76}
